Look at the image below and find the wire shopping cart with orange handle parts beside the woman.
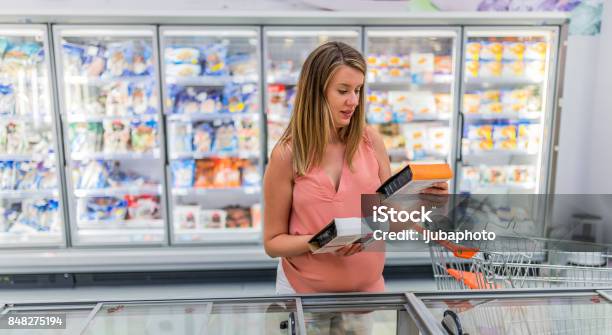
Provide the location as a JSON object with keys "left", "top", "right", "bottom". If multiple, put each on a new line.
{"left": 429, "top": 236, "right": 612, "bottom": 290}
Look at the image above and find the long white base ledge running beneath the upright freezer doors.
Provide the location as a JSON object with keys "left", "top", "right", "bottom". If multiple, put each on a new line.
{"left": 0, "top": 248, "right": 431, "bottom": 274}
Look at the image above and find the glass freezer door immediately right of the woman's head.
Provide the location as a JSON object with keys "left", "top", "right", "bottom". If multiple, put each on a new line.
{"left": 365, "top": 28, "right": 459, "bottom": 173}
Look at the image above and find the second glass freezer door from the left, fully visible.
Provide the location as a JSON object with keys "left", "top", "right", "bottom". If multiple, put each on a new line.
{"left": 54, "top": 26, "right": 166, "bottom": 245}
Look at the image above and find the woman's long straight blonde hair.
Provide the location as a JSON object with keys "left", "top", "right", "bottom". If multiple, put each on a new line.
{"left": 279, "top": 42, "right": 366, "bottom": 176}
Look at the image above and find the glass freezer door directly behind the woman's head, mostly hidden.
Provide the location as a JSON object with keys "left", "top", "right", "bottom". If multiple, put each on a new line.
{"left": 264, "top": 27, "right": 361, "bottom": 155}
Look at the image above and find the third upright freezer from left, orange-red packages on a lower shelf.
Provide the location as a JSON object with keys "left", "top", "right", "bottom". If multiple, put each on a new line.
{"left": 160, "top": 26, "right": 263, "bottom": 243}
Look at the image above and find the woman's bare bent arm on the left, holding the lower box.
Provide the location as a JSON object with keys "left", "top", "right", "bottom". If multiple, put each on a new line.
{"left": 263, "top": 144, "right": 312, "bottom": 257}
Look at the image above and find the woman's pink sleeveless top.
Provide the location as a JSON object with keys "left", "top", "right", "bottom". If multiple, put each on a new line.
{"left": 282, "top": 131, "right": 385, "bottom": 293}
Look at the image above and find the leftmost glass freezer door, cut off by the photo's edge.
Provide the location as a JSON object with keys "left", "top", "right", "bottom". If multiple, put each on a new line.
{"left": 0, "top": 25, "right": 66, "bottom": 248}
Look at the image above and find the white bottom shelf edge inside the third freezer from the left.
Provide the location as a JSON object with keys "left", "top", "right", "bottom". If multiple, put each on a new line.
{"left": 173, "top": 228, "right": 261, "bottom": 244}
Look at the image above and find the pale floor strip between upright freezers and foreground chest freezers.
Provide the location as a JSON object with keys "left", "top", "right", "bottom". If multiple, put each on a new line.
{"left": 0, "top": 279, "right": 435, "bottom": 305}
